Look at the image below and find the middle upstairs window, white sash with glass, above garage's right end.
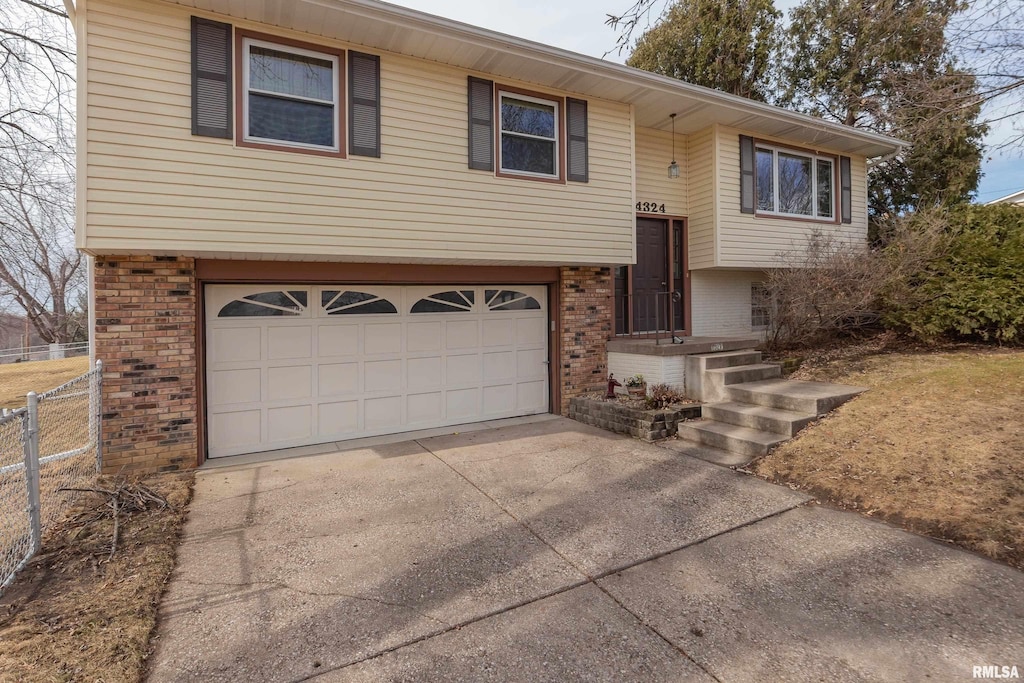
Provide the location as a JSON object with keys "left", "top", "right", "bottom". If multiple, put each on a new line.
{"left": 499, "top": 92, "right": 560, "bottom": 178}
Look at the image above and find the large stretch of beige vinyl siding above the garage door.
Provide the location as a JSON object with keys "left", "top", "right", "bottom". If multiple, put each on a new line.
{"left": 80, "top": 0, "right": 634, "bottom": 264}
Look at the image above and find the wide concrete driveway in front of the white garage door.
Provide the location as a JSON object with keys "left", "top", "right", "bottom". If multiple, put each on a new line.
{"left": 150, "top": 419, "right": 1024, "bottom": 681}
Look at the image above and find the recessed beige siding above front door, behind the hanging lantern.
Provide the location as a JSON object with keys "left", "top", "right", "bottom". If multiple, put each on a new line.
{"left": 636, "top": 128, "right": 689, "bottom": 216}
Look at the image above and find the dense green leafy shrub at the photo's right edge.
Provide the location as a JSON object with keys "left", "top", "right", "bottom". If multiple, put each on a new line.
{"left": 885, "top": 204, "right": 1024, "bottom": 344}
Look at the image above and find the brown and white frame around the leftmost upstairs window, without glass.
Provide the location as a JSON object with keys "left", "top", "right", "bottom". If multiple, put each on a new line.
{"left": 234, "top": 28, "right": 348, "bottom": 159}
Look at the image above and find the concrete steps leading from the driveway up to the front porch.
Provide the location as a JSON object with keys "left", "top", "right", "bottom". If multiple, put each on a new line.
{"left": 677, "top": 350, "right": 864, "bottom": 464}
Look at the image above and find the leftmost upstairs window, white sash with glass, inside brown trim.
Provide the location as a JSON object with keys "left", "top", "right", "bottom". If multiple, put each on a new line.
{"left": 242, "top": 37, "right": 341, "bottom": 154}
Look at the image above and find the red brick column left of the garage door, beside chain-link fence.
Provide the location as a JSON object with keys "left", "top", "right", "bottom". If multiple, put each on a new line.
{"left": 94, "top": 256, "right": 199, "bottom": 473}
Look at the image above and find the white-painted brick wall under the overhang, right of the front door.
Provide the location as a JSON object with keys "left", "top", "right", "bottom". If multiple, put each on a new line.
{"left": 690, "top": 270, "right": 765, "bottom": 336}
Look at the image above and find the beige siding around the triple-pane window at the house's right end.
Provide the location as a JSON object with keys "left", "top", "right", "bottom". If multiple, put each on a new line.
{"left": 716, "top": 127, "right": 867, "bottom": 268}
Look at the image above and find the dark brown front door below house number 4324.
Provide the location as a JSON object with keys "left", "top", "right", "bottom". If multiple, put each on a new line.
{"left": 633, "top": 218, "right": 669, "bottom": 332}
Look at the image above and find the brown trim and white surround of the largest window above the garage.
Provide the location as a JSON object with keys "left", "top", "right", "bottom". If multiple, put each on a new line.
{"left": 234, "top": 28, "right": 348, "bottom": 159}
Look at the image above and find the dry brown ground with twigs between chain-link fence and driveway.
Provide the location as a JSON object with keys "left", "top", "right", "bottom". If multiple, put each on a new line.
{"left": 0, "top": 473, "right": 193, "bottom": 683}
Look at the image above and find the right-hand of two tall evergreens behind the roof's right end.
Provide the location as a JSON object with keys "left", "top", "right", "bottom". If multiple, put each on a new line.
{"left": 779, "top": 0, "right": 986, "bottom": 216}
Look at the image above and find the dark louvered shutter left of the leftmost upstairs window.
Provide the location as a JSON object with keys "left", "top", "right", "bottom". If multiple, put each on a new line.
{"left": 191, "top": 16, "right": 233, "bottom": 138}
